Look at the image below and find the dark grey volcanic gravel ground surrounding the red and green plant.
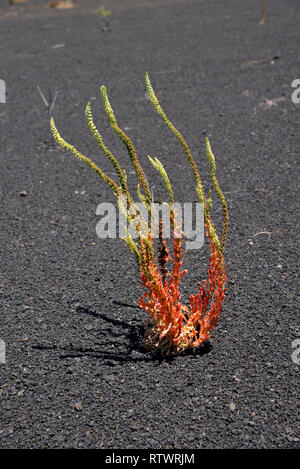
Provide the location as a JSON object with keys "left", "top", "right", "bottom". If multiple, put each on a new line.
{"left": 0, "top": 0, "right": 300, "bottom": 449}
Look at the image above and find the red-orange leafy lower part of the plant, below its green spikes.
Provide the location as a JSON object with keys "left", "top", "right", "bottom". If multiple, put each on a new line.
{"left": 139, "top": 214, "right": 227, "bottom": 356}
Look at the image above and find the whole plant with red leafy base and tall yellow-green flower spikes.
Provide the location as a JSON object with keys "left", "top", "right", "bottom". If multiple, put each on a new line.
{"left": 50, "top": 74, "right": 228, "bottom": 356}
